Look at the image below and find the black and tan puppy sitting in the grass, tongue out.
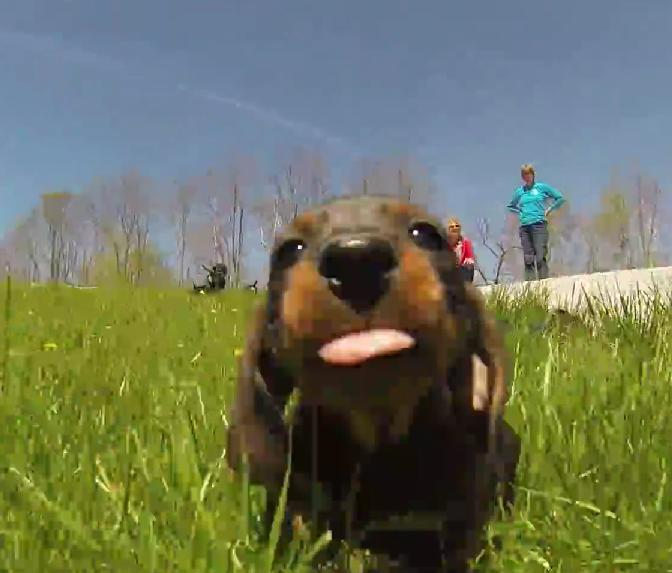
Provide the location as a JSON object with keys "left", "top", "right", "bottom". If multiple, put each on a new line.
{"left": 227, "top": 195, "right": 520, "bottom": 572}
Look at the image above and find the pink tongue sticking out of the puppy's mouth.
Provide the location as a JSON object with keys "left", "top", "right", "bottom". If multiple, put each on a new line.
{"left": 318, "top": 329, "right": 415, "bottom": 366}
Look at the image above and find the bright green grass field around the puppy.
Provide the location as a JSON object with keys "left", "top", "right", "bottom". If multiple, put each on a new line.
{"left": 0, "top": 285, "right": 672, "bottom": 573}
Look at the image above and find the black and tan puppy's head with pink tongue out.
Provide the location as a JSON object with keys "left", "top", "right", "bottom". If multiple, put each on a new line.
{"left": 242, "top": 196, "right": 504, "bottom": 450}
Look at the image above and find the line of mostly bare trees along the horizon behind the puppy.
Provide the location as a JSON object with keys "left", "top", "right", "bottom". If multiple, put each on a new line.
{"left": 0, "top": 149, "right": 669, "bottom": 286}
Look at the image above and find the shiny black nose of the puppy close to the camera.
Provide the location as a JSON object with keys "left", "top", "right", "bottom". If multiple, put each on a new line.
{"left": 320, "top": 237, "right": 397, "bottom": 312}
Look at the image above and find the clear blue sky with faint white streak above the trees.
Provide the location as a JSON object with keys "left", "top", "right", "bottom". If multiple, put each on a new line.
{"left": 0, "top": 0, "right": 672, "bottom": 274}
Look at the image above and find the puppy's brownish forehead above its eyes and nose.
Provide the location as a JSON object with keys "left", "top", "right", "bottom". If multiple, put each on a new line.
{"left": 279, "top": 195, "right": 443, "bottom": 244}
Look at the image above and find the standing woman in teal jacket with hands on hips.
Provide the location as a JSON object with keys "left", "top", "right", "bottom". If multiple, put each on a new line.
{"left": 506, "top": 164, "right": 565, "bottom": 281}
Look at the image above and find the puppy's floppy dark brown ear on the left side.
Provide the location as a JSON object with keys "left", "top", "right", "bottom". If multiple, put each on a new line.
{"left": 227, "top": 305, "right": 293, "bottom": 488}
